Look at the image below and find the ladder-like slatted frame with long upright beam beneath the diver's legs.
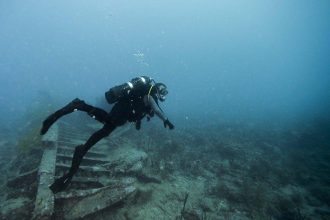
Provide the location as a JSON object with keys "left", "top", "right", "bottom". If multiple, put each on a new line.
{"left": 33, "top": 123, "right": 136, "bottom": 219}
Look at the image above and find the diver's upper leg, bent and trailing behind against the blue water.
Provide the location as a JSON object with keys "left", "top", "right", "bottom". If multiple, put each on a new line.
{"left": 40, "top": 98, "right": 108, "bottom": 135}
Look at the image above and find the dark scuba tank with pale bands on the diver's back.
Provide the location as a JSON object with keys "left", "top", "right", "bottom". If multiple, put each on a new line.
{"left": 105, "top": 76, "right": 153, "bottom": 104}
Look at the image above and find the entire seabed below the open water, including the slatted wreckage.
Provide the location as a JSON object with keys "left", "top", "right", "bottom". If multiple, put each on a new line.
{"left": 0, "top": 117, "right": 330, "bottom": 220}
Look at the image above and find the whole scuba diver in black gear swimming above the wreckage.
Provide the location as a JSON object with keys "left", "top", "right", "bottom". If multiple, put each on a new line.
{"left": 40, "top": 76, "right": 174, "bottom": 193}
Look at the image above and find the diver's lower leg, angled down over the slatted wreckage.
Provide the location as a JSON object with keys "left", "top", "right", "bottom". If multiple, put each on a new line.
{"left": 49, "top": 124, "right": 117, "bottom": 193}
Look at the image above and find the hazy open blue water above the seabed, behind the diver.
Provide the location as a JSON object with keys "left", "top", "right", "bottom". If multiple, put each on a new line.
{"left": 0, "top": 0, "right": 330, "bottom": 218}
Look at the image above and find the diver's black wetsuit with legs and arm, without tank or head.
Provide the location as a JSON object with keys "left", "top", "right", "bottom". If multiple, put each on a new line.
{"left": 40, "top": 87, "right": 174, "bottom": 193}
